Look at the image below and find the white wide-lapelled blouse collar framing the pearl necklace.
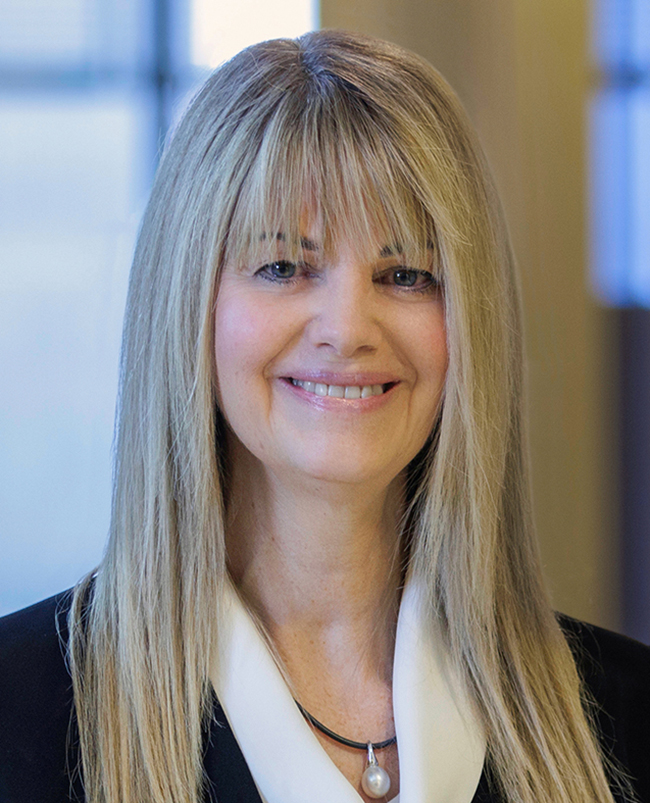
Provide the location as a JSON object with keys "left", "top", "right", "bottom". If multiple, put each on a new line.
{"left": 211, "top": 580, "right": 486, "bottom": 803}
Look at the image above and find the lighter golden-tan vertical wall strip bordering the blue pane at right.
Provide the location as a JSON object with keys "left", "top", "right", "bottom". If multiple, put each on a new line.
{"left": 511, "top": 0, "right": 618, "bottom": 626}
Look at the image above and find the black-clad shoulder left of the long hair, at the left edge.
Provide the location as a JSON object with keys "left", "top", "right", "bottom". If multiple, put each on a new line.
{"left": 0, "top": 592, "right": 81, "bottom": 803}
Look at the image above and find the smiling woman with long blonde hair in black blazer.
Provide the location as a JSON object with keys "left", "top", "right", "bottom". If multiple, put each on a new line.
{"left": 0, "top": 26, "right": 650, "bottom": 803}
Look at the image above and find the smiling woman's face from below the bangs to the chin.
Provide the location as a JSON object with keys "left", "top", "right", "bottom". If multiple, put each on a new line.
{"left": 215, "top": 221, "right": 447, "bottom": 485}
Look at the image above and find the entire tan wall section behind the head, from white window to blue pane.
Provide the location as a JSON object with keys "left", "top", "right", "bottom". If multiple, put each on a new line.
{"left": 321, "top": 0, "right": 618, "bottom": 626}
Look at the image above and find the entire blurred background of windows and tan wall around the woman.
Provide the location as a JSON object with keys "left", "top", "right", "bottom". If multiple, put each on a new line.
{"left": 0, "top": 0, "right": 650, "bottom": 643}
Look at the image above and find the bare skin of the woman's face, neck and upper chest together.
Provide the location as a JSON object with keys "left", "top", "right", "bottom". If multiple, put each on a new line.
{"left": 215, "top": 226, "right": 447, "bottom": 801}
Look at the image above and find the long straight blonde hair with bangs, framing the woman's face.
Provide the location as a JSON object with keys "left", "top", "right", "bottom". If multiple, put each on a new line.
{"left": 70, "top": 31, "right": 624, "bottom": 803}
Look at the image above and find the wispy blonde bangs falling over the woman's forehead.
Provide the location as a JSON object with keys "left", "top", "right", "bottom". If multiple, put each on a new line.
{"left": 220, "top": 76, "right": 441, "bottom": 275}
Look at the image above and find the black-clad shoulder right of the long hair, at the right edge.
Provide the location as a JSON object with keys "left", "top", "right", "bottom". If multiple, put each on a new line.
{"left": 558, "top": 616, "right": 650, "bottom": 801}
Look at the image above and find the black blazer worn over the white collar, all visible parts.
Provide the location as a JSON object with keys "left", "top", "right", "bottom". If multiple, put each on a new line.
{"left": 0, "top": 592, "right": 650, "bottom": 803}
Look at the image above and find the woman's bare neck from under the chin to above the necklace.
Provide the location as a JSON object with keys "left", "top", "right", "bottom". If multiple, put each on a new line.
{"left": 227, "top": 446, "right": 403, "bottom": 671}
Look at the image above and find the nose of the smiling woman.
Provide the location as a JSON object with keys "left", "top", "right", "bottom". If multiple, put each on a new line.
{"left": 310, "top": 263, "right": 381, "bottom": 358}
